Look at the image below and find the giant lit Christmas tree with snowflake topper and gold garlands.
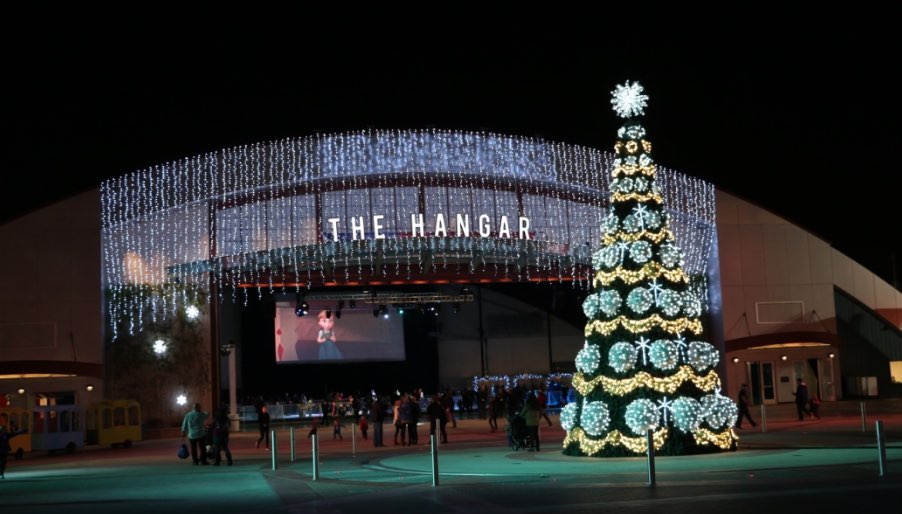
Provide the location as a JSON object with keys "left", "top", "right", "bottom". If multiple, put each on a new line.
{"left": 561, "top": 82, "right": 737, "bottom": 456}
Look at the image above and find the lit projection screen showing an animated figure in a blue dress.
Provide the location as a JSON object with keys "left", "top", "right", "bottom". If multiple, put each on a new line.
{"left": 275, "top": 302, "right": 405, "bottom": 364}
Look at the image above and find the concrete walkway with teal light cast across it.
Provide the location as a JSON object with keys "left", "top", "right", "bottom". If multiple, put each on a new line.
{"left": 0, "top": 400, "right": 902, "bottom": 514}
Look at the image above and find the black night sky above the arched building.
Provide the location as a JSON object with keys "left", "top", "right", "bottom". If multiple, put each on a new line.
{"left": 0, "top": 16, "right": 902, "bottom": 283}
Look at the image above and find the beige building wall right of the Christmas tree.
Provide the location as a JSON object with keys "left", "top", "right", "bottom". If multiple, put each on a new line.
{"left": 717, "top": 191, "right": 902, "bottom": 402}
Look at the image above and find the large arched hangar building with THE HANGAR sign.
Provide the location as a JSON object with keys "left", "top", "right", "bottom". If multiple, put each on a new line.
{"left": 0, "top": 131, "right": 902, "bottom": 424}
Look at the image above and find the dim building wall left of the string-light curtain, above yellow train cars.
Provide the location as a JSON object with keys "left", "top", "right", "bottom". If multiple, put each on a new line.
{"left": 0, "top": 189, "right": 104, "bottom": 403}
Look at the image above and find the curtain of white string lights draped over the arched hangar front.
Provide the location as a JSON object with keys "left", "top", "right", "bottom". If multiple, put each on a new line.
{"left": 100, "top": 130, "right": 715, "bottom": 338}
